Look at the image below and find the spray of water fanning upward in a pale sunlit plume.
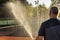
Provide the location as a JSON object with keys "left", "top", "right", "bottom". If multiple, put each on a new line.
{"left": 7, "top": 1, "right": 34, "bottom": 40}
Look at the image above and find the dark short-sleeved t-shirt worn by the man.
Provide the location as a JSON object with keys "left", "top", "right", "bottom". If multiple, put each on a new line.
{"left": 38, "top": 18, "right": 60, "bottom": 40}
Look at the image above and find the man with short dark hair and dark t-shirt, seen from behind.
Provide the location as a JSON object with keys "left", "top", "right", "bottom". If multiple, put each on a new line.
{"left": 36, "top": 7, "right": 60, "bottom": 40}
